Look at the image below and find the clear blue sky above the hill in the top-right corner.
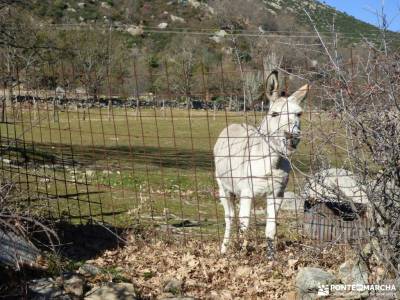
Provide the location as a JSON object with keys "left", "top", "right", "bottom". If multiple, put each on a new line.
{"left": 320, "top": 0, "right": 400, "bottom": 31}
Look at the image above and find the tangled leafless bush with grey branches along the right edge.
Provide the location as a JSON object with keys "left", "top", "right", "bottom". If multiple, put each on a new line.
{"left": 304, "top": 9, "right": 400, "bottom": 288}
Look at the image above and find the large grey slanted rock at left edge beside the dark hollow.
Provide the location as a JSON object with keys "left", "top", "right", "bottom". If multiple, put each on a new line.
{"left": 0, "top": 229, "right": 40, "bottom": 269}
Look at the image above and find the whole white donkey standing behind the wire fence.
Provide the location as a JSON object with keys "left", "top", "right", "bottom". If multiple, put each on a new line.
{"left": 214, "top": 71, "right": 309, "bottom": 257}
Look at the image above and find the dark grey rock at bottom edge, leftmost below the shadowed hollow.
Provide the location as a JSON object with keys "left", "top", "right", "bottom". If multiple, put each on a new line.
{"left": 28, "top": 278, "right": 66, "bottom": 299}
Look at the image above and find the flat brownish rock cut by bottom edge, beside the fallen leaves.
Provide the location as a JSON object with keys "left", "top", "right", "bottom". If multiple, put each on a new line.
{"left": 85, "top": 283, "right": 138, "bottom": 300}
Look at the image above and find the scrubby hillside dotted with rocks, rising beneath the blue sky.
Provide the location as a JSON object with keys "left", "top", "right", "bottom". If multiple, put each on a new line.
{"left": 0, "top": 0, "right": 391, "bottom": 100}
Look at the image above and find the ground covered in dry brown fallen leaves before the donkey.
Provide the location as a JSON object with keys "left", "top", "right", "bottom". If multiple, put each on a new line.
{"left": 90, "top": 236, "right": 346, "bottom": 299}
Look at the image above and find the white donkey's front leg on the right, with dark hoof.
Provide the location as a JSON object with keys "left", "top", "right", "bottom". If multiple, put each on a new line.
{"left": 265, "top": 194, "right": 282, "bottom": 259}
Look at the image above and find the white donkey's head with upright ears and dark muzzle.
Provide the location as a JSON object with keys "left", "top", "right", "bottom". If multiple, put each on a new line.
{"left": 261, "top": 71, "right": 309, "bottom": 155}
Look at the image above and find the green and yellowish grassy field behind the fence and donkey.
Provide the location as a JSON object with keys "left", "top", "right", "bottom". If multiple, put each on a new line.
{"left": 0, "top": 107, "right": 345, "bottom": 239}
